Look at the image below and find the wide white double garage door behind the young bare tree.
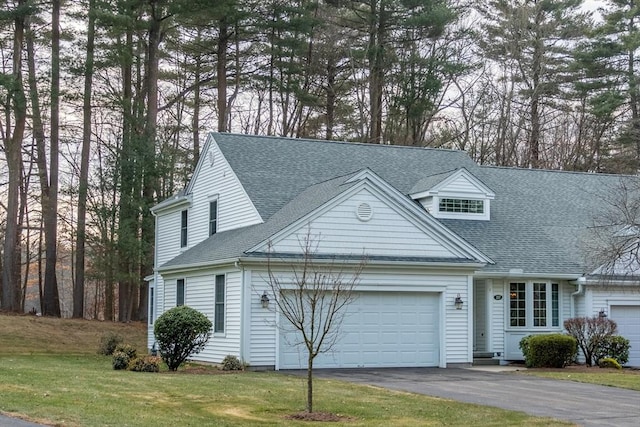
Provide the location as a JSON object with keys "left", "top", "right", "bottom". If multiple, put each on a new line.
{"left": 279, "top": 292, "right": 440, "bottom": 369}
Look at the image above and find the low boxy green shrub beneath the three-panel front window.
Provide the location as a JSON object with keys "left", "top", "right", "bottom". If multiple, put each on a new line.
{"left": 520, "top": 334, "right": 578, "bottom": 368}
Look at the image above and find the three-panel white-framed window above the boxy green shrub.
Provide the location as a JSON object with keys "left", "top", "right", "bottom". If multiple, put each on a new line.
{"left": 509, "top": 282, "right": 560, "bottom": 328}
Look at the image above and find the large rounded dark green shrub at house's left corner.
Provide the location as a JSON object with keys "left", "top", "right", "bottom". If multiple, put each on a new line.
{"left": 153, "top": 305, "right": 212, "bottom": 371}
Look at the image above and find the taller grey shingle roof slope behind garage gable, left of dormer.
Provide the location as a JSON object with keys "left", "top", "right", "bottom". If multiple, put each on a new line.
{"left": 211, "top": 133, "right": 475, "bottom": 220}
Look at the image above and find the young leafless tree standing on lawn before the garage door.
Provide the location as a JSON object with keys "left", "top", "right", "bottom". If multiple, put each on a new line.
{"left": 268, "top": 231, "right": 366, "bottom": 412}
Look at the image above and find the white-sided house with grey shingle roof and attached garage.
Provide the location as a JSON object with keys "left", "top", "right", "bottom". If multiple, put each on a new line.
{"left": 148, "top": 133, "right": 640, "bottom": 369}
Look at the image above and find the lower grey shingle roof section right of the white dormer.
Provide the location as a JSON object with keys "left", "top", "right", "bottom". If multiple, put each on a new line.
{"left": 441, "top": 166, "right": 624, "bottom": 278}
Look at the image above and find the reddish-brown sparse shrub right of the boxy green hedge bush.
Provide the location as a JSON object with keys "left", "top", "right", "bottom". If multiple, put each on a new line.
{"left": 564, "top": 316, "right": 618, "bottom": 366}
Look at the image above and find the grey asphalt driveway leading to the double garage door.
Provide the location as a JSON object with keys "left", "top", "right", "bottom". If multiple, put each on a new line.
{"left": 284, "top": 367, "right": 640, "bottom": 427}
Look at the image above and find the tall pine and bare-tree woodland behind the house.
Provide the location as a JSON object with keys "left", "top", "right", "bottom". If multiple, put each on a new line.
{"left": 0, "top": 0, "right": 640, "bottom": 321}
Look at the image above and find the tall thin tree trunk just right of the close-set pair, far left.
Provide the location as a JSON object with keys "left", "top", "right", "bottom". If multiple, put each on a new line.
{"left": 73, "top": 0, "right": 96, "bottom": 318}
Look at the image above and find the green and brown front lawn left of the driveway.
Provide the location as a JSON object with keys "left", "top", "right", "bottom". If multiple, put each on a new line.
{"left": 0, "top": 316, "right": 571, "bottom": 427}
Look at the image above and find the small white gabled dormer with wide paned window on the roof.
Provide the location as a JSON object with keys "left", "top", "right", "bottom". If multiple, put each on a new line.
{"left": 409, "top": 168, "right": 495, "bottom": 221}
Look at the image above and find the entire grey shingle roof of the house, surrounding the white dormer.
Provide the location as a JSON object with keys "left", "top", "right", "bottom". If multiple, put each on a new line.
{"left": 163, "top": 133, "right": 632, "bottom": 276}
